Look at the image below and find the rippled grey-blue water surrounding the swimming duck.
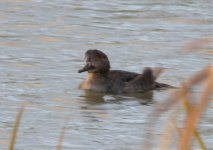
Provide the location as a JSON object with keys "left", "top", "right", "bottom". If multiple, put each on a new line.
{"left": 0, "top": 0, "right": 213, "bottom": 150}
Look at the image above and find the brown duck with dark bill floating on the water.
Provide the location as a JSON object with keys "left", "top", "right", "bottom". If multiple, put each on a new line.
{"left": 79, "top": 49, "right": 169, "bottom": 93}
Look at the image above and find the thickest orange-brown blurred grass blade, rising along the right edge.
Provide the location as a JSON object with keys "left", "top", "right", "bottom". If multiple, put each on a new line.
{"left": 179, "top": 66, "right": 213, "bottom": 150}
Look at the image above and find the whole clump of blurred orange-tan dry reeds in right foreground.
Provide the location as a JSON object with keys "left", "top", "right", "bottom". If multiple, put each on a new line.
{"left": 145, "top": 38, "right": 213, "bottom": 150}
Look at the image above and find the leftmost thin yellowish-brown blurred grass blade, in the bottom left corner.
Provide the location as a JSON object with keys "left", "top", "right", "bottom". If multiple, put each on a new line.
{"left": 9, "top": 104, "right": 25, "bottom": 150}
